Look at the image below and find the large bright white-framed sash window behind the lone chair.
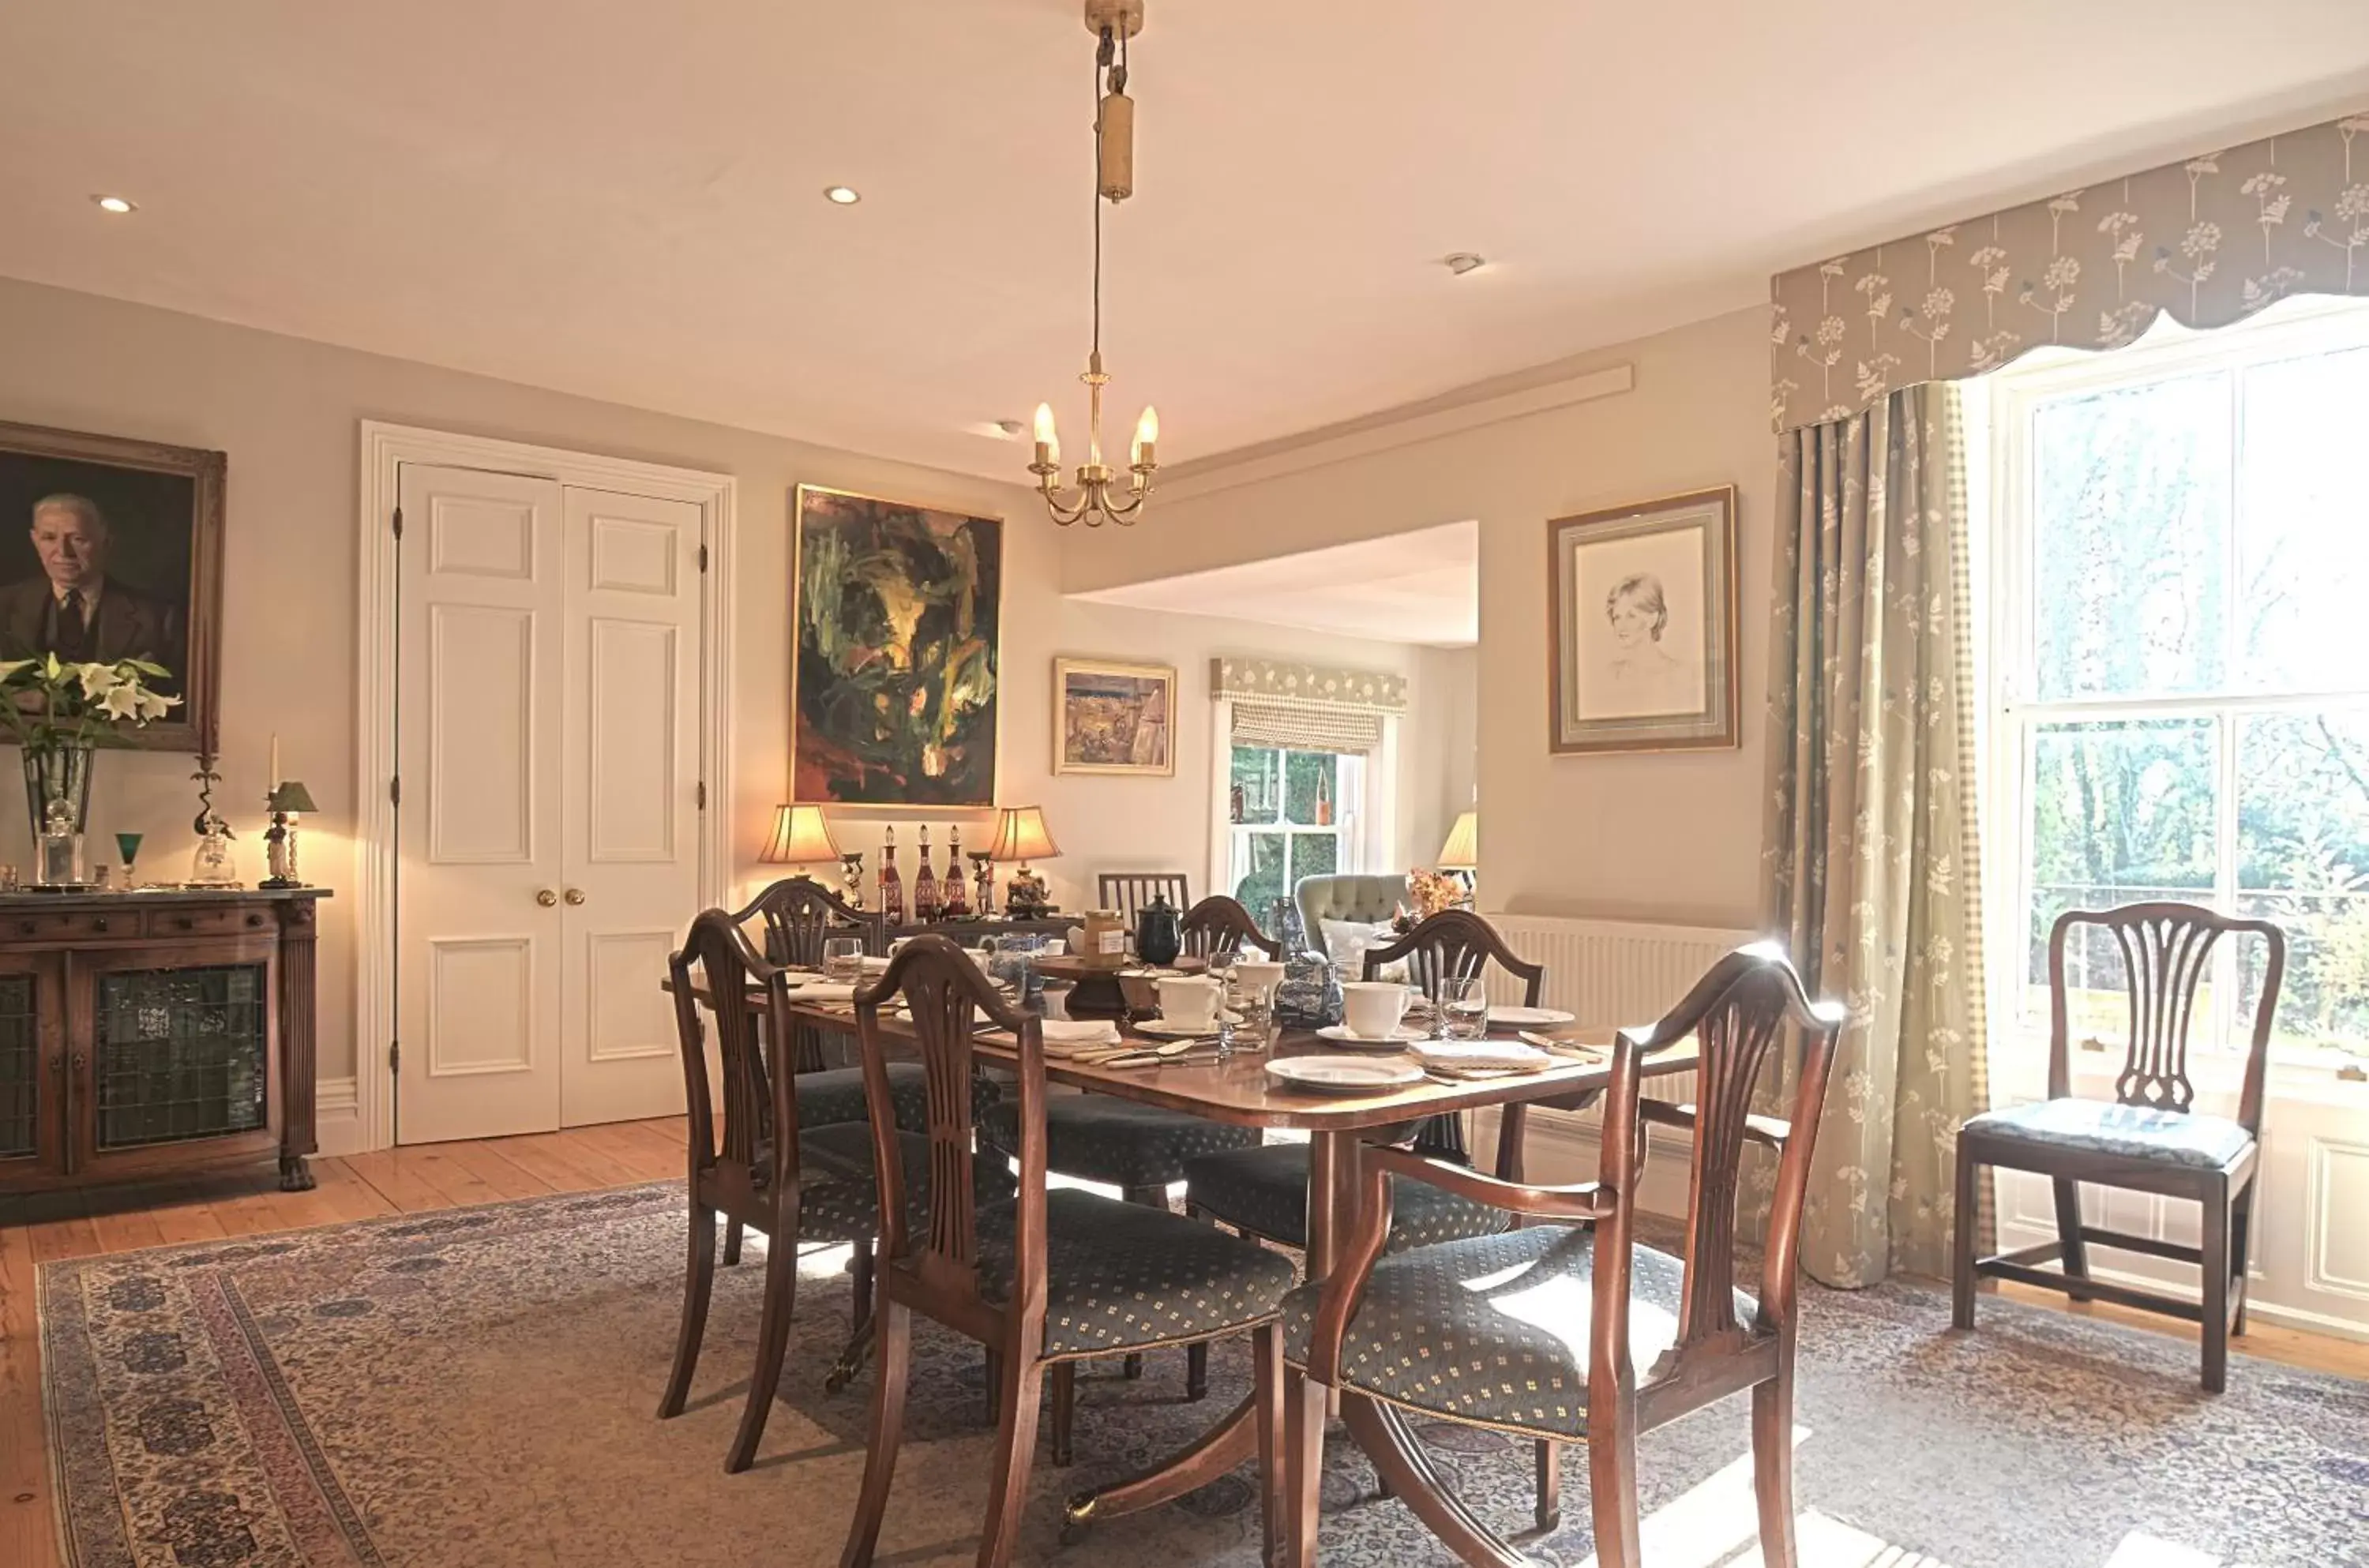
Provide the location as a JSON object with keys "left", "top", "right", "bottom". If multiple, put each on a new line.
{"left": 1988, "top": 306, "right": 2369, "bottom": 1066}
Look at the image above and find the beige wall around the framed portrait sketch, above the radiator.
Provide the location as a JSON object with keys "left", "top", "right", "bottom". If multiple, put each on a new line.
{"left": 1094, "top": 308, "right": 1774, "bottom": 926}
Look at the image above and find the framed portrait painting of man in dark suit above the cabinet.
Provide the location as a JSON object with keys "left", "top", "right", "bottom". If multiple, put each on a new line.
{"left": 0, "top": 424, "right": 227, "bottom": 751}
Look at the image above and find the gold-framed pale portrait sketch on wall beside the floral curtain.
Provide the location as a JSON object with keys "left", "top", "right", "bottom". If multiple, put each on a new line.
{"left": 1547, "top": 486, "right": 1736, "bottom": 753}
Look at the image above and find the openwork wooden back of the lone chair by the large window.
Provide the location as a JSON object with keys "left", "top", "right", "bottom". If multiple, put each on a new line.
{"left": 2049, "top": 902, "right": 2286, "bottom": 1137}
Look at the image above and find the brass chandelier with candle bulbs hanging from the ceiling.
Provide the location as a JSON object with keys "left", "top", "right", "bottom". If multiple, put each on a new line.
{"left": 1028, "top": 0, "right": 1161, "bottom": 528}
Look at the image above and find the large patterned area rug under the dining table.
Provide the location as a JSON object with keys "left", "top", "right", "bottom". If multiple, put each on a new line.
{"left": 40, "top": 1187, "right": 2369, "bottom": 1568}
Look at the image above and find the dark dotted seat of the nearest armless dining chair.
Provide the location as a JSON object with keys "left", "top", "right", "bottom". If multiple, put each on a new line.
{"left": 978, "top": 1187, "right": 1296, "bottom": 1357}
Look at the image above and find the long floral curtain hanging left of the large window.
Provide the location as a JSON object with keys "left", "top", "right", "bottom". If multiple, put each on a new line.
{"left": 1755, "top": 386, "right": 1990, "bottom": 1286}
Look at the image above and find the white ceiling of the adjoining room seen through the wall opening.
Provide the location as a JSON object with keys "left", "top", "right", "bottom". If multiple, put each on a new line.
{"left": 1071, "top": 521, "right": 1481, "bottom": 647}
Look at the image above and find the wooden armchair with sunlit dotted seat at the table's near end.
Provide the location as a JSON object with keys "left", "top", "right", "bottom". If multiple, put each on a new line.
{"left": 1284, "top": 943, "right": 1843, "bottom": 1568}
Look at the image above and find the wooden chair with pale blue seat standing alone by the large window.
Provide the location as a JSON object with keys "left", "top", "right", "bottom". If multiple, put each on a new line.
{"left": 1950, "top": 902, "right": 2286, "bottom": 1393}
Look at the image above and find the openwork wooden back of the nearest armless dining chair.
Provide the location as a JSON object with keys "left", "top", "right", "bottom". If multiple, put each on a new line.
{"left": 855, "top": 936, "right": 1045, "bottom": 1341}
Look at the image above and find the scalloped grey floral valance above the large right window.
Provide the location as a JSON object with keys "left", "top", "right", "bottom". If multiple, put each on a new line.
{"left": 1770, "top": 114, "right": 2369, "bottom": 431}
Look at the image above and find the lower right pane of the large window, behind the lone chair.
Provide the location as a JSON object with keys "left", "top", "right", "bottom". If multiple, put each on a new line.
{"left": 2236, "top": 708, "right": 2369, "bottom": 1054}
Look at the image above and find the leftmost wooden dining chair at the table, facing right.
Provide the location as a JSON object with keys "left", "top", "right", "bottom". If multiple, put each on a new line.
{"left": 659, "top": 910, "right": 1012, "bottom": 1473}
